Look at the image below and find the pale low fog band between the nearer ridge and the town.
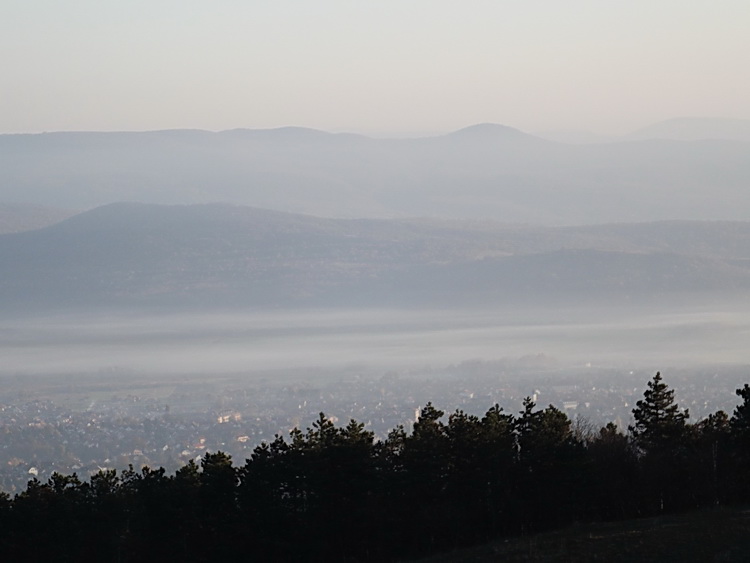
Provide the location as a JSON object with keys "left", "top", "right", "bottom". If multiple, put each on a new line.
{"left": 0, "top": 303, "right": 750, "bottom": 375}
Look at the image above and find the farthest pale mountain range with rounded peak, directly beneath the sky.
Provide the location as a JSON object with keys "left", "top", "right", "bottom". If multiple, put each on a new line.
{"left": 0, "top": 120, "right": 750, "bottom": 225}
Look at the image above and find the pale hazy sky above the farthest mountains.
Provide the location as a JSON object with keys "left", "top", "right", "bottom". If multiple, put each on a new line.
{"left": 0, "top": 0, "right": 750, "bottom": 134}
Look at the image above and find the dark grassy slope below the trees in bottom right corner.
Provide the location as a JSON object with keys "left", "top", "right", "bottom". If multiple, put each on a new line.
{"left": 420, "top": 507, "right": 750, "bottom": 563}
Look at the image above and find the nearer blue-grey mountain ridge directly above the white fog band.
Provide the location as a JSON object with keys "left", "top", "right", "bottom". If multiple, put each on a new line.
{"left": 0, "top": 203, "right": 750, "bottom": 311}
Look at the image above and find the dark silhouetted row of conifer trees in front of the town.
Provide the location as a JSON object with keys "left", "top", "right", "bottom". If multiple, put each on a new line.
{"left": 0, "top": 373, "right": 750, "bottom": 561}
